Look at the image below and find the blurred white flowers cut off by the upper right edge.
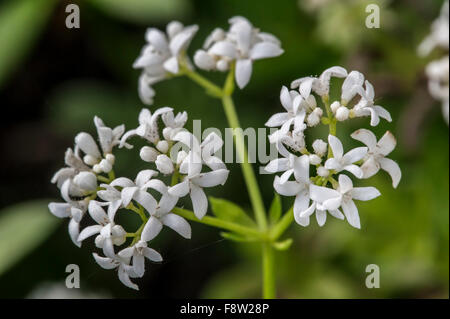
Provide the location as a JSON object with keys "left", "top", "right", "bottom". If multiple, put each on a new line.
{"left": 418, "top": 0, "right": 449, "bottom": 124}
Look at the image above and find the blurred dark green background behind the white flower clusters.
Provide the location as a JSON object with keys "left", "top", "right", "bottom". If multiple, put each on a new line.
{"left": 0, "top": 0, "right": 449, "bottom": 298}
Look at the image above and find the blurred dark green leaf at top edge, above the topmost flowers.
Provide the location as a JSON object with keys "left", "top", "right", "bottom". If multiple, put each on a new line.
{"left": 90, "top": 0, "right": 190, "bottom": 24}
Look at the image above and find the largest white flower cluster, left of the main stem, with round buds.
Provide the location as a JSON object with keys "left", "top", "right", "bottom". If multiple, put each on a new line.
{"left": 49, "top": 107, "right": 229, "bottom": 289}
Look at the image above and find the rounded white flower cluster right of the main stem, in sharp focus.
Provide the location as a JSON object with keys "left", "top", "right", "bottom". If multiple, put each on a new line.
{"left": 265, "top": 66, "right": 401, "bottom": 228}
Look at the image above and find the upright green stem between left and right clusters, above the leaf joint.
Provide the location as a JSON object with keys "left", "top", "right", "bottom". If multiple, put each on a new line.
{"left": 222, "top": 95, "right": 267, "bottom": 230}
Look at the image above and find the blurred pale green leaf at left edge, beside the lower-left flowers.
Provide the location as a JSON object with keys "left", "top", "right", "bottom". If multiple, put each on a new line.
{"left": 0, "top": 201, "right": 60, "bottom": 275}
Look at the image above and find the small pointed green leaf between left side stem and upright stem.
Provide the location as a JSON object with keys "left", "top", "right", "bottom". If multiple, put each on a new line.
{"left": 209, "top": 197, "right": 256, "bottom": 227}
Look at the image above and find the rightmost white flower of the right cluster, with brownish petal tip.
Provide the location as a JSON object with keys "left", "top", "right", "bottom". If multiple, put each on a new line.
{"left": 351, "top": 129, "right": 402, "bottom": 188}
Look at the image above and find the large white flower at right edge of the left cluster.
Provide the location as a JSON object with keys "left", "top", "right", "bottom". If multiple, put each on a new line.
{"left": 169, "top": 132, "right": 229, "bottom": 219}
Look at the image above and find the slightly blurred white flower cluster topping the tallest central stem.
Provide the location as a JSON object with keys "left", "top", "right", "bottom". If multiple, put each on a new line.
{"left": 133, "top": 16, "right": 283, "bottom": 105}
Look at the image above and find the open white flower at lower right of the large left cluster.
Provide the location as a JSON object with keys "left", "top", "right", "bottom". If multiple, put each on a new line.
{"left": 141, "top": 180, "right": 191, "bottom": 241}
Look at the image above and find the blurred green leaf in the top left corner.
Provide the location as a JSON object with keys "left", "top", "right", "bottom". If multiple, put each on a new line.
{"left": 0, "top": 0, "right": 56, "bottom": 87}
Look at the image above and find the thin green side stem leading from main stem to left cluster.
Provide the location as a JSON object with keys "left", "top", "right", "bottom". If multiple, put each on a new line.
{"left": 172, "top": 207, "right": 266, "bottom": 239}
